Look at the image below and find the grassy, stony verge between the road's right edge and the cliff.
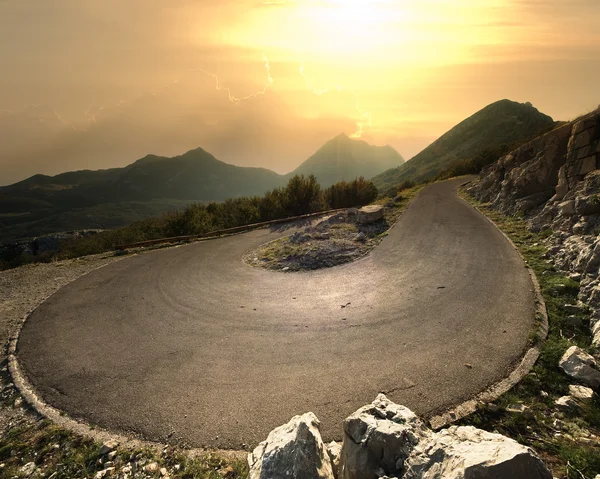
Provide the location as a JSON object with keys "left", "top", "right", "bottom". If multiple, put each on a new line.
{"left": 461, "top": 192, "right": 600, "bottom": 479}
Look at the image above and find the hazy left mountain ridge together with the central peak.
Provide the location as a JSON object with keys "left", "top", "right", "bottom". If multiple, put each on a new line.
{"left": 0, "top": 135, "right": 404, "bottom": 241}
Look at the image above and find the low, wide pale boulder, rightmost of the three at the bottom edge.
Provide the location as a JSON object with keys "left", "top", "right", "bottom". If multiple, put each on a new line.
{"left": 403, "top": 426, "right": 552, "bottom": 479}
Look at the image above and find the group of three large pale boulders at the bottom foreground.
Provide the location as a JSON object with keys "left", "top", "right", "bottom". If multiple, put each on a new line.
{"left": 248, "top": 394, "right": 552, "bottom": 479}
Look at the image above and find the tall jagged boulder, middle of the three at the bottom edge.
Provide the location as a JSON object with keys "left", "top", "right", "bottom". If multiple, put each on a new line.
{"left": 338, "top": 394, "right": 432, "bottom": 479}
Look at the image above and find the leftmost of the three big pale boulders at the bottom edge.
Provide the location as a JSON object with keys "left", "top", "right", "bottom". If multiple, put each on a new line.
{"left": 248, "top": 412, "right": 334, "bottom": 479}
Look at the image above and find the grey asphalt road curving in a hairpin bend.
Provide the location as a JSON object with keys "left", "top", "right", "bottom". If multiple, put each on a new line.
{"left": 17, "top": 180, "right": 534, "bottom": 448}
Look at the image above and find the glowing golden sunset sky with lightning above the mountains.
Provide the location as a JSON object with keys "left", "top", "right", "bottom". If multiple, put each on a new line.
{"left": 0, "top": 0, "right": 600, "bottom": 185}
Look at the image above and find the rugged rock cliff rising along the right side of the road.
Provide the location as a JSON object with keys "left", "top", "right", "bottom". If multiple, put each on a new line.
{"left": 467, "top": 108, "right": 600, "bottom": 346}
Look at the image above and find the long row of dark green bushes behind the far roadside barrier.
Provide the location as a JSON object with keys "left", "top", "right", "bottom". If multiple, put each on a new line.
{"left": 0, "top": 175, "right": 377, "bottom": 269}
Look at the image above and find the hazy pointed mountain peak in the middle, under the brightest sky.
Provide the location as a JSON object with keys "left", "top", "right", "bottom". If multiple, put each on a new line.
{"left": 287, "top": 134, "right": 404, "bottom": 187}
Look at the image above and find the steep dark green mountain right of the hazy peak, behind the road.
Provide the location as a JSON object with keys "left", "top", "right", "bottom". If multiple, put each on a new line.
{"left": 373, "top": 100, "right": 555, "bottom": 190}
